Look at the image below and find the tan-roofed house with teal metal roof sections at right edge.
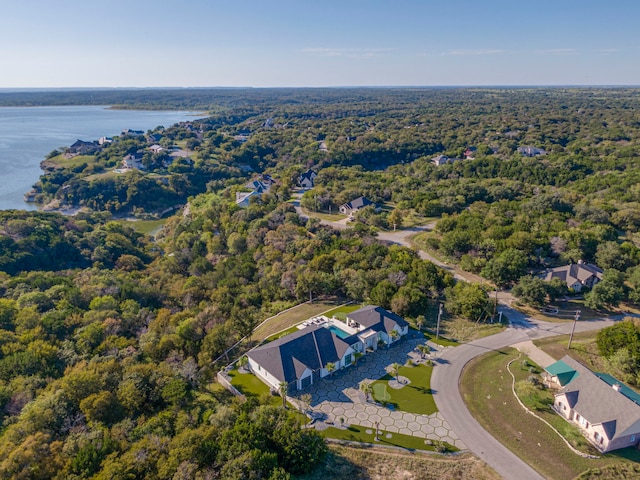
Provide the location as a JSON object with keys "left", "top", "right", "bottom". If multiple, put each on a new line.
{"left": 545, "top": 355, "right": 640, "bottom": 452}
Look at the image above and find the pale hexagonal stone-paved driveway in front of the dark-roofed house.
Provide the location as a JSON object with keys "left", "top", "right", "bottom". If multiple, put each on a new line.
{"left": 298, "top": 336, "right": 466, "bottom": 449}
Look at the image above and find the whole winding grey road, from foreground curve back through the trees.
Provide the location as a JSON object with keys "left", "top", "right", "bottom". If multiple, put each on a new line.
{"left": 296, "top": 211, "right": 614, "bottom": 480}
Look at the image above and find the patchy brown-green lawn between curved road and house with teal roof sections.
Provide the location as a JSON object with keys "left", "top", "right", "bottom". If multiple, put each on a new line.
{"left": 460, "top": 349, "right": 640, "bottom": 480}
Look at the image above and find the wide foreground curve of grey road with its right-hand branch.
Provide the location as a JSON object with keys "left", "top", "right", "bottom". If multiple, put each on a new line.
{"left": 431, "top": 307, "right": 613, "bottom": 480}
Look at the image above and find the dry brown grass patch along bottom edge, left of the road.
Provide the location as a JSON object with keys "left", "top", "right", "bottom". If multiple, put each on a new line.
{"left": 296, "top": 444, "right": 501, "bottom": 480}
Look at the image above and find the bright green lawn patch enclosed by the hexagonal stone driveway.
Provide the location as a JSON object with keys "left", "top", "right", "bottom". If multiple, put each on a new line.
{"left": 372, "top": 365, "right": 438, "bottom": 415}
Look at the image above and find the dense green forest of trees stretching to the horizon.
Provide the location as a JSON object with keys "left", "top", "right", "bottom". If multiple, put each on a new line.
{"left": 0, "top": 88, "right": 640, "bottom": 480}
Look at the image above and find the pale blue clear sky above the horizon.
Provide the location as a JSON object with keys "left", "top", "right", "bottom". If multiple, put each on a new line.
{"left": 0, "top": 0, "right": 640, "bottom": 88}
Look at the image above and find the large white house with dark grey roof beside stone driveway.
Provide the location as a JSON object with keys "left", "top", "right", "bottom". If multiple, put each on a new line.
{"left": 247, "top": 306, "right": 409, "bottom": 392}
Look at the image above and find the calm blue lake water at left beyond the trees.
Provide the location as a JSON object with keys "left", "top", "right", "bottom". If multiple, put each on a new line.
{"left": 0, "top": 106, "right": 200, "bottom": 210}
